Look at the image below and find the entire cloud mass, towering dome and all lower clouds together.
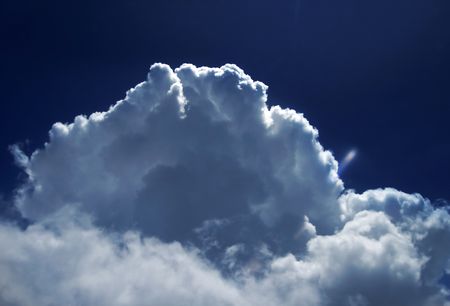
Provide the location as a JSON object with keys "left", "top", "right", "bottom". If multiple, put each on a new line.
{"left": 0, "top": 64, "right": 450, "bottom": 306}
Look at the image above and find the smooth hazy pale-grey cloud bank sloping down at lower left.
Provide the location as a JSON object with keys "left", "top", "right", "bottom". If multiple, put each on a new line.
{"left": 0, "top": 215, "right": 246, "bottom": 305}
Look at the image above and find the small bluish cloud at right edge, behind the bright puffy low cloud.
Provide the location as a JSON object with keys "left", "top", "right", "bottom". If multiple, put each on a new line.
{"left": 339, "top": 188, "right": 450, "bottom": 283}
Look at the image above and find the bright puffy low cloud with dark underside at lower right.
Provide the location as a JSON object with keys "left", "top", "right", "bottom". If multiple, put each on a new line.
{"left": 266, "top": 211, "right": 430, "bottom": 305}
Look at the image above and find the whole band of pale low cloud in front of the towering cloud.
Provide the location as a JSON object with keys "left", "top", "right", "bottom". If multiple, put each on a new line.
{"left": 0, "top": 211, "right": 443, "bottom": 306}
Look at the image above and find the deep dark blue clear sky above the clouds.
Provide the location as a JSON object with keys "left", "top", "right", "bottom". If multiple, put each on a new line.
{"left": 0, "top": 0, "right": 450, "bottom": 199}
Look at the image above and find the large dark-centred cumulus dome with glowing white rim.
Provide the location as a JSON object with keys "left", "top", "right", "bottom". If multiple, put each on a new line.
{"left": 16, "top": 64, "right": 343, "bottom": 251}
